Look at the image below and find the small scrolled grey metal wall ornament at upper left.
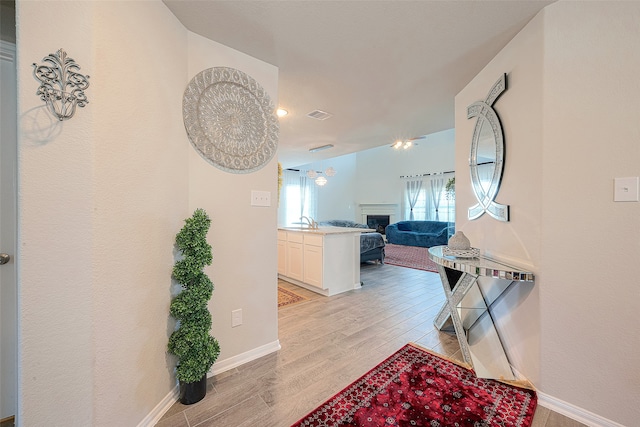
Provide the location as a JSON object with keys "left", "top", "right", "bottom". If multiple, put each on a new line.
{"left": 33, "top": 49, "right": 89, "bottom": 121}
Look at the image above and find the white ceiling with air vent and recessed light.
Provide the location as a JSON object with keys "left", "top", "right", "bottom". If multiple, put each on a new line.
{"left": 164, "top": 0, "right": 553, "bottom": 168}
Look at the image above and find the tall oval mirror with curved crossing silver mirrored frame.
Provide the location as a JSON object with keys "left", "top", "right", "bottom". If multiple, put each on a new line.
{"left": 467, "top": 74, "right": 509, "bottom": 221}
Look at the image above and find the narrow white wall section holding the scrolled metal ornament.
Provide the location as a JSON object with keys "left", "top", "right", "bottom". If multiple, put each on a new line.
{"left": 16, "top": 2, "right": 100, "bottom": 426}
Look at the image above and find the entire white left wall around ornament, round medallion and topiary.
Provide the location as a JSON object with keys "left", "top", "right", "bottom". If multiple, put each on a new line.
{"left": 17, "top": 1, "right": 277, "bottom": 426}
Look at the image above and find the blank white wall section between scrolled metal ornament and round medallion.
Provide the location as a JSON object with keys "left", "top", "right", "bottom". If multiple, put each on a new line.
{"left": 90, "top": 1, "right": 191, "bottom": 426}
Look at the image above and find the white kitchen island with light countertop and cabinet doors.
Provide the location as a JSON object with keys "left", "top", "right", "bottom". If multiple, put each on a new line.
{"left": 278, "top": 227, "right": 375, "bottom": 296}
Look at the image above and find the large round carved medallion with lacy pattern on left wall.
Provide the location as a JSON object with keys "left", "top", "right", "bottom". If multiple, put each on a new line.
{"left": 182, "top": 67, "right": 279, "bottom": 173}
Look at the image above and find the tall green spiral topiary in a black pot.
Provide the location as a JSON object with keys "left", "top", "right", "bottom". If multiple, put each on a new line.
{"left": 168, "top": 209, "right": 220, "bottom": 405}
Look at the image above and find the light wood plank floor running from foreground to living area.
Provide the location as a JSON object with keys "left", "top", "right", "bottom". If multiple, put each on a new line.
{"left": 157, "top": 264, "right": 583, "bottom": 427}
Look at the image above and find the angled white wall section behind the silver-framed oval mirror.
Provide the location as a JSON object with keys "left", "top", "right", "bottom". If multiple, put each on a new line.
{"left": 455, "top": 9, "right": 543, "bottom": 385}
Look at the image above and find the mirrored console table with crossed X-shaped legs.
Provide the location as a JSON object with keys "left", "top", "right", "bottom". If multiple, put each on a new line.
{"left": 429, "top": 246, "right": 534, "bottom": 380}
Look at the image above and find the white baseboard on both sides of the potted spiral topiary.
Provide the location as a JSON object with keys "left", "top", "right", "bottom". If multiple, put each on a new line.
{"left": 137, "top": 340, "right": 281, "bottom": 427}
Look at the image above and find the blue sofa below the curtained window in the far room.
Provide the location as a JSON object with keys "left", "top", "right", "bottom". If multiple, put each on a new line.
{"left": 386, "top": 221, "right": 455, "bottom": 248}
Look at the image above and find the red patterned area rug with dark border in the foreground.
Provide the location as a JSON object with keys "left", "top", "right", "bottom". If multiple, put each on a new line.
{"left": 292, "top": 344, "right": 537, "bottom": 427}
